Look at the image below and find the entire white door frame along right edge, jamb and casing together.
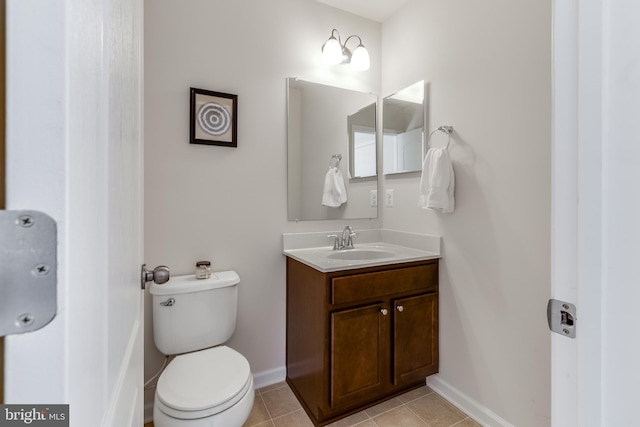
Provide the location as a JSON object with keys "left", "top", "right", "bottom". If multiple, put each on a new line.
{"left": 552, "top": 0, "right": 640, "bottom": 427}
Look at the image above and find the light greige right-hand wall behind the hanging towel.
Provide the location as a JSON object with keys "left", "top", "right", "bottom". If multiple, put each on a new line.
{"left": 382, "top": 0, "right": 551, "bottom": 427}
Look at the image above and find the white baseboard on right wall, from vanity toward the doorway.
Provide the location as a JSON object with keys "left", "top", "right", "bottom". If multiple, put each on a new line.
{"left": 427, "top": 374, "right": 514, "bottom": 427}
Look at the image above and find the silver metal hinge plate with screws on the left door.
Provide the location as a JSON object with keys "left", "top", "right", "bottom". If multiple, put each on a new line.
{"left": 0, "top": 210, "right": 57, "bottom": 336}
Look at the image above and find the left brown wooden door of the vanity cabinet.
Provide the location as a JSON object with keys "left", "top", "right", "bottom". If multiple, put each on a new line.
{"left": 330, "top": 304, "right": 391, "bottom": 410}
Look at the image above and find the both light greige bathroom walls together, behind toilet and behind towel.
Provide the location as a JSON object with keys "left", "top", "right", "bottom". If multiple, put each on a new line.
{"left": 145, "top": 0, "right": 551, "bottom": 427}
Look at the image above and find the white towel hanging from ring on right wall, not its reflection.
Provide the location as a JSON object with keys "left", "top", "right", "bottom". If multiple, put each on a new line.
{"left": 418, "top": 147, "right": 455, "bottom": 213}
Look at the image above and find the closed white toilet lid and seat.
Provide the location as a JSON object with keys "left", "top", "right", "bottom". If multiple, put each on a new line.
{"left": 156, "top": 346, "right": 253, "bottom": 419}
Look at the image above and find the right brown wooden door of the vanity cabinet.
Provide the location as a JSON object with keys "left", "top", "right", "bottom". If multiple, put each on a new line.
{"left": 393, "top": 293, "right": 438, "bottom": 386}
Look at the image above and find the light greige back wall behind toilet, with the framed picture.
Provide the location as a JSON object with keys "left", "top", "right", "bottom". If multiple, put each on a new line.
{"left": 145, "top": 0, "right": 380, "bottom": 414}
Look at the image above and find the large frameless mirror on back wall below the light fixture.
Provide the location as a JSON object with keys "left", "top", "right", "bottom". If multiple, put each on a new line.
{"left": 287, "top": 78, "right": 378, "bottom": 221}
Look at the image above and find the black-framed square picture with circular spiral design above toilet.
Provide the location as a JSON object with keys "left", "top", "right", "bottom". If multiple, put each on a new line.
{"left": 189, "top": 87, "right": 238, "bottom": 147}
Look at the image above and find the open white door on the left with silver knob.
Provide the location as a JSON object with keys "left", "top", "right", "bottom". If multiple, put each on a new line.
{"left": 5, "top": 0, "right": 143, "bottom": 427}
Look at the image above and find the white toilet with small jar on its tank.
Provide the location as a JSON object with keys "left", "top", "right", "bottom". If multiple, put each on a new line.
{"left": 149, "top": 271, "right": 255, "bottom": 427}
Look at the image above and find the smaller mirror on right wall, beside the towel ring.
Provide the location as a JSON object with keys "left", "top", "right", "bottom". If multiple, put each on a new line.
{"left": 382, "top": 81, "right": 426, "bottom": 174}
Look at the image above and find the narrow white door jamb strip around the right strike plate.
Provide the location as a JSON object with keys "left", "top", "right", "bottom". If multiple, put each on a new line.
{"left": 551, "top": 0, "right": 584, "bottom": 427}
